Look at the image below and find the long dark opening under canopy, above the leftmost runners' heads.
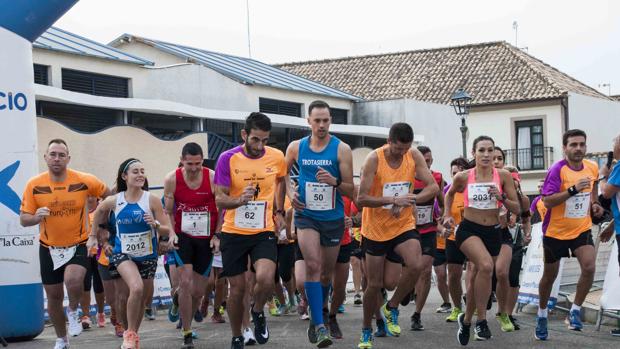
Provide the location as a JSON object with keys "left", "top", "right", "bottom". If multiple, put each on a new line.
{"left": 37, "top": 101, "right": 123, "bottom": 133}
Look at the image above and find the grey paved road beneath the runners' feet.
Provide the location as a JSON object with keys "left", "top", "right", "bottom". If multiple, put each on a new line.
{"left": 8, "top": 289, "right": 620, "bottom": 349}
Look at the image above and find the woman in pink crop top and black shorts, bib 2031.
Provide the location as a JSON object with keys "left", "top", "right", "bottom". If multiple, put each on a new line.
{"left": 444, "top": 136, "right": 519, "bottom": 345}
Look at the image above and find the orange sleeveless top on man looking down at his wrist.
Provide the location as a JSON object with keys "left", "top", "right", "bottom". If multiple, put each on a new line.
{"left": 362, "top": 145, "right": 415, "bottom": 241}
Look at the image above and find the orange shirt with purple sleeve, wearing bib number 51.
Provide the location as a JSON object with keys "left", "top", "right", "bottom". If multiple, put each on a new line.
{"left": 542, "top": 160, "right": 598, "bottom": 240}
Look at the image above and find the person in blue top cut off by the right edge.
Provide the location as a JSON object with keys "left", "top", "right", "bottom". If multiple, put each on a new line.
{"left": 600, "top": 135, "right": 620, "bottom": 337}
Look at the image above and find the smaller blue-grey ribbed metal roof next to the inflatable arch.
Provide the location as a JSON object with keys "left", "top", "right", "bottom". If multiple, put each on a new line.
{"left": 32, "top": 27, "right": 153, "bottom": 65}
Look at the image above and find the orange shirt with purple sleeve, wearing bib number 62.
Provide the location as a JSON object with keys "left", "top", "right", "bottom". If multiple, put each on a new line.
{"left": 214, "top": 145, "right": 286, "bottom": 235}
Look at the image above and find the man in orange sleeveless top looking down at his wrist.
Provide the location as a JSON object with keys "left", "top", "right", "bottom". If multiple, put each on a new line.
{"left": 358, "top": 123, "right": 439, "bottom": 348}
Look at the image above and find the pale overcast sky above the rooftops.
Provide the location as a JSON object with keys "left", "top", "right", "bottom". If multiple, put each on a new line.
{"left": 55, "top": 0, "right": 620, "bottom": 95}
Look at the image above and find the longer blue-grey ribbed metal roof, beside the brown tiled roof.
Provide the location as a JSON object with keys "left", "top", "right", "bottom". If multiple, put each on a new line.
{"left": 110, "top": 34, "right": 360, "bottom": 100}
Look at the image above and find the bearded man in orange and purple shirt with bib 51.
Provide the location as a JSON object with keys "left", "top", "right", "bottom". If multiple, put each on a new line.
{"left": 535, "top": 130, "right": 604, "bottom": 340}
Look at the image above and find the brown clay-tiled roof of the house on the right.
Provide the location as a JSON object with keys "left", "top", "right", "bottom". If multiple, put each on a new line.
{"left": 276, "top": 41, "right": 608, "bottom": 105}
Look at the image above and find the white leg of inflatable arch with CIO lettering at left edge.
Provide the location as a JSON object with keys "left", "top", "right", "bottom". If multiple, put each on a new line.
{"left": 0, "top": 27, "right": 41, "bottom": 286}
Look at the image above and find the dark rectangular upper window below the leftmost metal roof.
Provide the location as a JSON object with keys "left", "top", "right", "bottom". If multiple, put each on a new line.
{"left": 62, "top": 69, "right": 129, "bottom": 98}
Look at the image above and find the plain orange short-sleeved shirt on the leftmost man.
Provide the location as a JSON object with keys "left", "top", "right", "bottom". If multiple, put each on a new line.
{"left": 21, "top": 169, "right": 106, "bottom": 247}
